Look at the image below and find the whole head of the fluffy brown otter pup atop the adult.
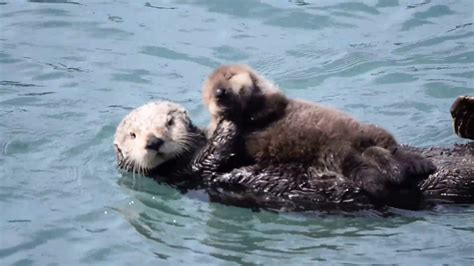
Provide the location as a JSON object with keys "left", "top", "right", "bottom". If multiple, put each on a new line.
{"left": 203, "top": 65, "right": 288, "bottom": 132}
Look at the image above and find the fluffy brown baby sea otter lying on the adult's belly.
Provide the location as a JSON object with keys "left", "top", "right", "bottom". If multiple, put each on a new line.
{"left": 203, "top": 65, "right": 436, "bottom": 200}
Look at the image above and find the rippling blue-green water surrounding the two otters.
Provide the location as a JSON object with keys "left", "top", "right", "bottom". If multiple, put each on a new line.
{"left": 0, "top": 0, "right": 474, "bottom": 265}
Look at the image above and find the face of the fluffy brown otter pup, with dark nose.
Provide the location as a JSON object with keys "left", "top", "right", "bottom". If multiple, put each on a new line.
{"left": 203, "top": 65, "right": 260, "bottom": 119}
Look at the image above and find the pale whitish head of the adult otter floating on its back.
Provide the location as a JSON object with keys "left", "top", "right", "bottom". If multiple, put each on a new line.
{"left": 114, "top": 101, "right": 200, "bottom": 174}
